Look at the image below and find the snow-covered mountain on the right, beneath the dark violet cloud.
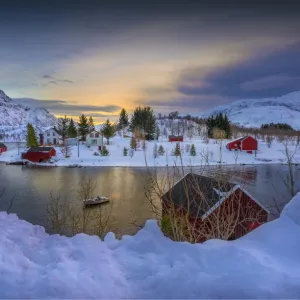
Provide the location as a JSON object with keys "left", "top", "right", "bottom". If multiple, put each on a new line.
{"left": 200, "top": 91, "right": 300, "bottom": 129}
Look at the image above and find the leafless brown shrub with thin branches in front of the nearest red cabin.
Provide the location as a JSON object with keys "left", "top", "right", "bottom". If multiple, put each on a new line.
{"left": 145, "top": 162, "right": 263, "bottom": 243}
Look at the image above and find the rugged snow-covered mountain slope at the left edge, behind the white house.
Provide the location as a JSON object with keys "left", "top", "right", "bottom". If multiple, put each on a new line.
{"left": 0, "top": 90, "right": 57, "bottom": 139}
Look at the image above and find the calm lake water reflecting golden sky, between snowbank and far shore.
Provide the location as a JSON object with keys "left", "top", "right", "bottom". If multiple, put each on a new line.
{"left": 0, "top": 164, "right": 300, "bottom": 236}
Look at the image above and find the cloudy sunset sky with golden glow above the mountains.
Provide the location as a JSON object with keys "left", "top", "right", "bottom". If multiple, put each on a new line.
{"left": 0, "top": 0, "right": 300, "bottom": 122}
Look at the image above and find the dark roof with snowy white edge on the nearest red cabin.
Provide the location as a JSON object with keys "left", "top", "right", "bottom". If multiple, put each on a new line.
{"left": 162, "top": 173, "right": 270, "bottom": 219}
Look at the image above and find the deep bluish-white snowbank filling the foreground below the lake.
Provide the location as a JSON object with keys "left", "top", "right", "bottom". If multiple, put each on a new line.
{"left": 0, "top": 194, "right": 300, "bottom": 298}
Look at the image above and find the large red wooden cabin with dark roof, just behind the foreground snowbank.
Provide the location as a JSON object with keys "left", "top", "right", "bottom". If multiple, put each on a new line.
{"left": 162, "top": 173, "right": 270, "bottom": 243}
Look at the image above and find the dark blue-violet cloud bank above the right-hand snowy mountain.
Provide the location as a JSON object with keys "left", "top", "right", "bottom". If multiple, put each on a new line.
{"left": 177, "top": 43, "right": 300, "bottom": 99}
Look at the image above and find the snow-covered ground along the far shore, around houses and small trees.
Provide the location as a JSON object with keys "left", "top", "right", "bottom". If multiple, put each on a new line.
{"left": 0, "top": 137, "right": 300, "bottom": 167}
